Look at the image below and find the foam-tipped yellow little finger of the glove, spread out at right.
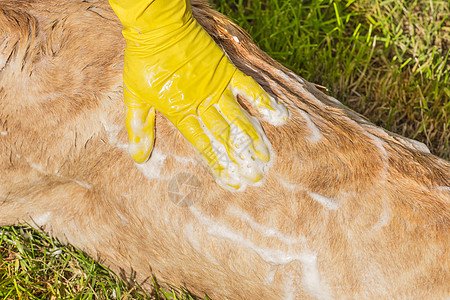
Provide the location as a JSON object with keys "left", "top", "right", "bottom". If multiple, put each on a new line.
{"left": 228, "top": 70, "right": 289, "bottom": 125}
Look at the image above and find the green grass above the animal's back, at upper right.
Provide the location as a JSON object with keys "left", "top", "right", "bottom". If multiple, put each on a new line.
{"left": 215, "top": 0, "right": 450, "bottom": 160}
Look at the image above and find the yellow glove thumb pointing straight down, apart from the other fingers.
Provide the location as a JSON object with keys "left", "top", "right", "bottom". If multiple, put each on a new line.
{"left": 125, "top": 103, "right": 155, "bottom": 164}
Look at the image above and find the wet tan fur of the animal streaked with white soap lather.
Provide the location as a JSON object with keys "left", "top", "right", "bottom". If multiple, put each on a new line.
{"left": 0, "top": 0, "right": 450, "bottom": 299}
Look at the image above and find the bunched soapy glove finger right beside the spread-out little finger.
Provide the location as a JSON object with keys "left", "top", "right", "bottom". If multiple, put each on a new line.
{"left": 218, "top": 89, "right": 270, "bottom": 162}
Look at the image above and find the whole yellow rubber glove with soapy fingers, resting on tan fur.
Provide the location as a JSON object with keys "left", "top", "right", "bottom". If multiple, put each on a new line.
{"left": 109, "top": 0, "right": 288, "bottom": 189}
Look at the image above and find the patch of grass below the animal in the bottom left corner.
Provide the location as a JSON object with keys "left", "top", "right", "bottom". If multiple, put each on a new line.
{"left": 0, "top": 226, "right": 197, "bottom": 300}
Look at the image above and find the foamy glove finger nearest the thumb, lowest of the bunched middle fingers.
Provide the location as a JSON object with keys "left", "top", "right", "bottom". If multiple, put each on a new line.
{"left": 176, "top": 115, "right": 241, "bottom": 189}
